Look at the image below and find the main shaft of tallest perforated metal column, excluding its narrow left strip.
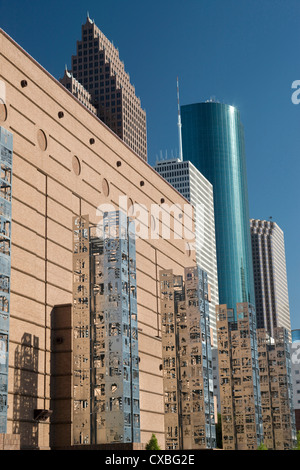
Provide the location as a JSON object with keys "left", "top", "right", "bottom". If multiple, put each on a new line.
{"left": 90, "top": 211, "right": 140, "bottom": 444}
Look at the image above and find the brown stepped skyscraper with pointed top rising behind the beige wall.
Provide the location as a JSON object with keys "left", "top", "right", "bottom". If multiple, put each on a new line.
{"left": 61, "top": 17, "right": 147, "bottom": 160}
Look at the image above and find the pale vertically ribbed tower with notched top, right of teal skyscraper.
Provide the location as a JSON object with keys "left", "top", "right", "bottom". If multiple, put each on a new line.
{"left": 250, "top": 219, "right": 291, "bottom": 340}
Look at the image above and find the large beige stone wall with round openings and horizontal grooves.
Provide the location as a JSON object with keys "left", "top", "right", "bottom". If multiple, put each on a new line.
{"left": 0, "top": 30, "right": 195, "bottom": 449}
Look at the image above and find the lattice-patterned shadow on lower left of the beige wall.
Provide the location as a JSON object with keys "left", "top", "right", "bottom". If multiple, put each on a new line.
{"left": 13, "top": 333, "right": 39, "bottom": 449}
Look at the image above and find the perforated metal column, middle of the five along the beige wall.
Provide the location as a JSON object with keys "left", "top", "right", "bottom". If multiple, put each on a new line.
{"left": 160, "top": 266, "right": 216, "bottom": 450}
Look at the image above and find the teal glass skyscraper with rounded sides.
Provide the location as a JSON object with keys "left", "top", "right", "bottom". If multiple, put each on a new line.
{"left": 181, "top": 101, "right": 255, "bottom": 312}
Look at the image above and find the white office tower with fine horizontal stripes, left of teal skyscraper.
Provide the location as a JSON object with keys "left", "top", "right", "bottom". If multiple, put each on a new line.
{"left": 154, "top": 158, "right": 219, "bottom": 345}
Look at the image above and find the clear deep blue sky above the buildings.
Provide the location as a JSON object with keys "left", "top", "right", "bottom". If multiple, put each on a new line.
{"left": 0, "top": 0, "right": 300, "bottom": 329}
